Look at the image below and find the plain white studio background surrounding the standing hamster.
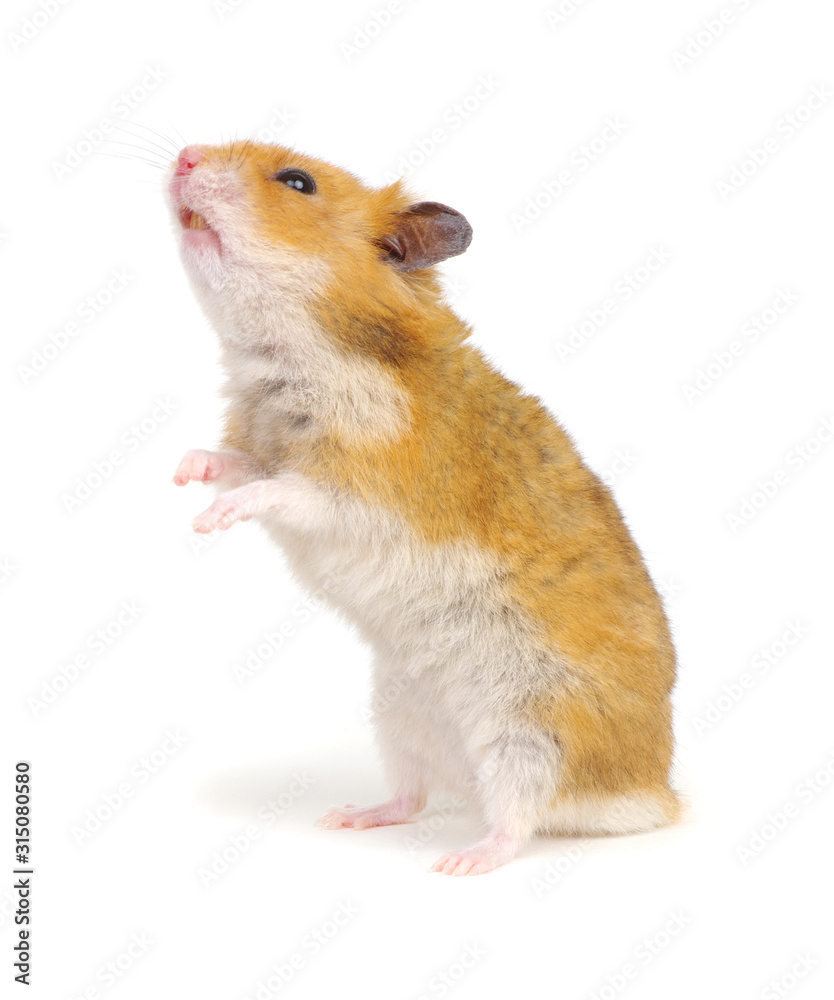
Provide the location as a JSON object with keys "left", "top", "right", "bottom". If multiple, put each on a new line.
{"left": 0, "top": 0, "right": 834, "bottom": 1000}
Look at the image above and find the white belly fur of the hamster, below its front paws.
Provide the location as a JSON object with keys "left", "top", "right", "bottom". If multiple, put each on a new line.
{"left": 262, "top": 474, "right": 566, "bottom": 806}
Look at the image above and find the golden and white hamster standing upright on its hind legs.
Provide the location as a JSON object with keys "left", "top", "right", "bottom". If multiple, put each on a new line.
{"left": 168, "top": 142, "right": 681, "bottom": 875}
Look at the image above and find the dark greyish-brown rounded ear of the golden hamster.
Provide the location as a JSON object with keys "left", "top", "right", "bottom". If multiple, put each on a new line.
{"left": 379, "top": 201, "right": 472, "bottom": 271}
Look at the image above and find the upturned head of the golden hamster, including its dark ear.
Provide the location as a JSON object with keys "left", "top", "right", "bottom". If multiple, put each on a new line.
{"left": 168, "top": 141, "right": 472, "bottom": 332}
